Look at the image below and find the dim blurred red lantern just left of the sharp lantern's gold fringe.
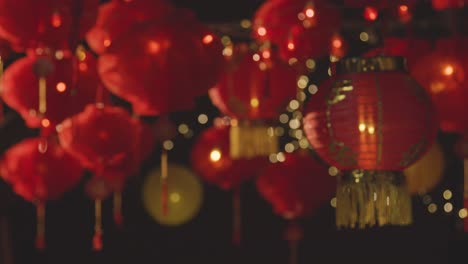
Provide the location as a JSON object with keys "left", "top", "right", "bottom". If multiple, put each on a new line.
{"left": 257, "top": 152, "right": 336, "bottom": 219}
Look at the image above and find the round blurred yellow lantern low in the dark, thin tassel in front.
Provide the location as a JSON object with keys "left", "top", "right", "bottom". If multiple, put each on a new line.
{"left": 143, "top": 164, "right": 203, "bottom": 226}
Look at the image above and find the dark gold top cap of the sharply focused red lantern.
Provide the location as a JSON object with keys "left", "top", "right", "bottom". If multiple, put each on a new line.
{"left": 335, "top": 56, "right": 408, "bottom": 75}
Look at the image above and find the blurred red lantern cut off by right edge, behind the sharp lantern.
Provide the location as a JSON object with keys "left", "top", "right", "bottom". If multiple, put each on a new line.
{"left": 411, "top": 40, "right": 468, "bottom": 133}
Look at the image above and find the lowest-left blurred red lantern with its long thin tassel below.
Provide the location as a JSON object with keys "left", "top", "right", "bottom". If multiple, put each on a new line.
{"left": 0, "top": 138, "right": 83, "bottom": 249}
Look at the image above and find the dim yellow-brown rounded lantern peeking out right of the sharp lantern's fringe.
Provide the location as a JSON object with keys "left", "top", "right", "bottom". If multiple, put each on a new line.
{"left": 404, "top": 143, "right": 445, "bottom": 194}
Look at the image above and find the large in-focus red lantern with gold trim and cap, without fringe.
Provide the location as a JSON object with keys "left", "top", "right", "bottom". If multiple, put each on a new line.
{"left": 304, "top": 57, "right": 437, "bottom": 171}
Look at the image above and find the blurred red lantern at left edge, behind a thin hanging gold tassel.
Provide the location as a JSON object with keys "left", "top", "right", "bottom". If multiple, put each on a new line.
{"left": 3, "top": 49, "right": 104, "bottom": 128}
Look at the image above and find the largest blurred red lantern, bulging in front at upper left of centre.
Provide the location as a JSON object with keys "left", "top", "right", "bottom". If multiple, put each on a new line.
{"left": 99, "top": 18, "right": 213, "bottom": 115}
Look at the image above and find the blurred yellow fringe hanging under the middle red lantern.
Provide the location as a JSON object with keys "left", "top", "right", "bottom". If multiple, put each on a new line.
{"left": 229, "top": 120, "right": 279, "bottom": 159}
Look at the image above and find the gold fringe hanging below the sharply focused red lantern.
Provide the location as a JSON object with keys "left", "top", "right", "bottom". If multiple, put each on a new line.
{"left": 336, "top": 170, "right": 412, "bottom": 229}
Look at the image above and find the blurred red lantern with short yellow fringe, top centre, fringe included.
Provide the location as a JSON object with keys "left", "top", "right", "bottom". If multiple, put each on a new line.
{"left": 209, "top": 45, "right": 297, "bottom": 159}
